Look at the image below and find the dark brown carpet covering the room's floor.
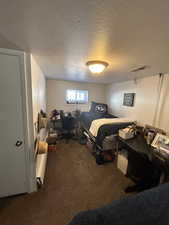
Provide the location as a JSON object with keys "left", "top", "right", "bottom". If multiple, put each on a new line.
{"left": 0, "top": 141, "right": 131, "bottom": 225}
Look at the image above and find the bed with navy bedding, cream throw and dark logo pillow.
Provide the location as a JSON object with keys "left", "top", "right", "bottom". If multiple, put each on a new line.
{"left": 80, "top": 102, "right": 133, "bottom": 150}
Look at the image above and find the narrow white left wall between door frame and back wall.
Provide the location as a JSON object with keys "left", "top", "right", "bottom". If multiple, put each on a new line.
{"left": 31, "top": 55, "right": 46, "bottom": 123}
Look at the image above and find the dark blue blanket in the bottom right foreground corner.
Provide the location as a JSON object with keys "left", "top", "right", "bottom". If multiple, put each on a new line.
{"left": 69, "top": 183, "right": 169, "bottom": 225}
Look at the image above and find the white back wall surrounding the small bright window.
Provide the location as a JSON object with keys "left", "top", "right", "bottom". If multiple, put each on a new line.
{"left": 47, "top": 80, "right": 106, "bottom": 113}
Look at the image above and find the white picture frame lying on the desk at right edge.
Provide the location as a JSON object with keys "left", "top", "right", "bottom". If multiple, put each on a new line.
{"left": 151, "top": 133, "right": 169, "bottom": 149}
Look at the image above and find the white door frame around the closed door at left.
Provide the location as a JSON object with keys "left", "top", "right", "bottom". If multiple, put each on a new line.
{"left": 0, "top": 48, "right": 37, "bottom": 193}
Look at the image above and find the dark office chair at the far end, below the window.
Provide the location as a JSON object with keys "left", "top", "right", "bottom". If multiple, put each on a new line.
{"left": 60, "top": 111, "right": 76, "bottom": 143}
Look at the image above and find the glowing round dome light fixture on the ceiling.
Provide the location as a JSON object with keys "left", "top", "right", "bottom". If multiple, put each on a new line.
{"left": 86, "top": 60, "right": 109, "bottom": 73}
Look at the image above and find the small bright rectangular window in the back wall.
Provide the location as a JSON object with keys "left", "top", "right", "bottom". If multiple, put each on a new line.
{"left": 66, "top": 90, "right": 88, "bottom": 104}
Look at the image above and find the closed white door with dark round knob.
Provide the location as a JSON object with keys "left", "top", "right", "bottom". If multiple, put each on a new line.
{"left": 0, "top": 52, "right": 27, "bottom": 197}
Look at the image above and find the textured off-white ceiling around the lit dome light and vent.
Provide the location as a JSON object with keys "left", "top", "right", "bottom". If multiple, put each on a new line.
{"left": 0, "top": 0, "right": 169, "bottom": 83}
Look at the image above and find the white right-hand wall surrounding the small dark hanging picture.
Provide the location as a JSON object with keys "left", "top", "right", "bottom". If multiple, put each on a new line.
{"left": 106, "top": 75, "right": 169, "bottom": 131}
